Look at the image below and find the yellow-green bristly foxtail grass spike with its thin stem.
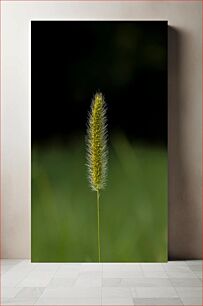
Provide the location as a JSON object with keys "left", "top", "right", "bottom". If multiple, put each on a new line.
{"left": 87, "top": 93, "right": 108, "bottom": 262}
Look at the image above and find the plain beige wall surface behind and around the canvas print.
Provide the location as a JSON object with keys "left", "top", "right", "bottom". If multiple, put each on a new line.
{"left": 1, "top": 1, "right": 202, "bottom": 259}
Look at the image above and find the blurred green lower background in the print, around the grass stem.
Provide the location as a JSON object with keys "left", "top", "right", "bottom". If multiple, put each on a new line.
{"left": 32, "top": 134, "right": 167, "bottom": 262}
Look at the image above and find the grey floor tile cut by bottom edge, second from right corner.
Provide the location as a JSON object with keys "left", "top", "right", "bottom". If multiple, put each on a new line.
{"left": 133, "top": 298, "right": 183, "bottom": 306}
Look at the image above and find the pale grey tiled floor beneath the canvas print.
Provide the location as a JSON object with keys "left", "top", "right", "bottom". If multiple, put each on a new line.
{"left": 1, "top": 260, "right": 202, "bottom": 306}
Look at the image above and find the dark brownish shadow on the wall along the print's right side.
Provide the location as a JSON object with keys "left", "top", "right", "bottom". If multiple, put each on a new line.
{"left": 168, "top": 27, "right": 202, "bottom": 260}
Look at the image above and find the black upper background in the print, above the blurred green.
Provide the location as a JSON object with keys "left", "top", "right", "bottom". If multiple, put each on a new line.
{"left": 31, "top": 21, "right": 167, "bottom": 145}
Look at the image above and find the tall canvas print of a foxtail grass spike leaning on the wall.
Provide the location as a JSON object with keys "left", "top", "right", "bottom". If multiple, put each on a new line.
{"left": 31, "top": 21, "right": 168, "bottom": 262}
